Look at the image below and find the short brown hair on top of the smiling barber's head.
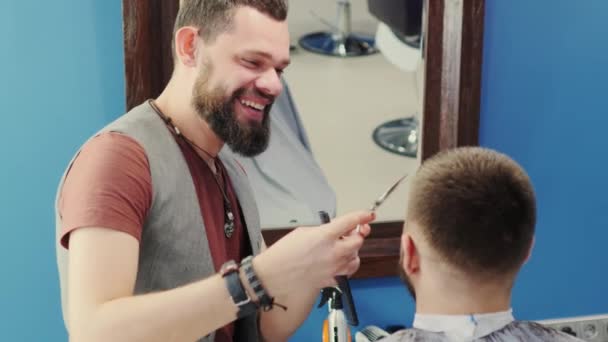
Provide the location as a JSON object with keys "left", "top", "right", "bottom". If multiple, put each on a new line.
{"left": 173, "top": 0, "right": 287, "bottom": 41}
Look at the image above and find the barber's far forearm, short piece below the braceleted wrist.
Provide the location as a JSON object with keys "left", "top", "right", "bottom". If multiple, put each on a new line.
{"left": 260, "top": 288, "right": 319, "bottom": 341}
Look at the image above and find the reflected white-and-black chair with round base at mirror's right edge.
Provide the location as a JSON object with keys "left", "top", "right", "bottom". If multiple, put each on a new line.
{"left": 368, "top": 0, "right": 423, "bottom": 157}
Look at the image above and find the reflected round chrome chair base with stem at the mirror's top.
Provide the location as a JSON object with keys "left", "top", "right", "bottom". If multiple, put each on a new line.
{"left": 300, "top": 0, "right": 378, "bottom": 57}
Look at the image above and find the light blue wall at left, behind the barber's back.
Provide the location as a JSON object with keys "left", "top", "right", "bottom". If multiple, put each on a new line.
{"left": 0, "top": 0, "right": 125, "bottom": 341}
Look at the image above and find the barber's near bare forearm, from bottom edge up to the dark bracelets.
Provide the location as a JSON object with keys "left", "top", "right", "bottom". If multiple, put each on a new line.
{"left": 70, "top": 275, "right": 237, "bottom": 342}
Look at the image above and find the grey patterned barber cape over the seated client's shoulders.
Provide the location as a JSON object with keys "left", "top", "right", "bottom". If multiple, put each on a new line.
{"left": 381, "top": 321, "right": 582, "bottom": 342}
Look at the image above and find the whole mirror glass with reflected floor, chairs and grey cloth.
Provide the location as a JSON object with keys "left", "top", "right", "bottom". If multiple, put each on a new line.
{"left": 226, "top": 0, "right": 423, "bottom": 229}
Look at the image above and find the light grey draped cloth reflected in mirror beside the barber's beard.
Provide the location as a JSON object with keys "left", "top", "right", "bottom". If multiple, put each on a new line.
{"left": 222, "top": 80, "right": 336, "bottom": 228}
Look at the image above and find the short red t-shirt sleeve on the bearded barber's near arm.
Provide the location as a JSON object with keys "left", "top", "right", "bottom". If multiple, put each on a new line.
{"left": 59, "top": 132, "right": 152, "bottom": 248}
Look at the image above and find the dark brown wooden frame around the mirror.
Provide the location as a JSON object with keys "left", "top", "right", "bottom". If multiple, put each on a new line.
{"left": 123, "top": 0, "right": 485, "bottom": 278}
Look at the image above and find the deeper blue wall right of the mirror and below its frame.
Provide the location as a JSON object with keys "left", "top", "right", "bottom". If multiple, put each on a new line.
{"left": 293, "top": 0, "right": 608, "bottom": 342}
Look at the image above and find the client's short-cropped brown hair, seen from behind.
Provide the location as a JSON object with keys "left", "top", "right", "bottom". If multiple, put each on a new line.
{"left": 408, "top": 147, "right": 536, "bottom": 278}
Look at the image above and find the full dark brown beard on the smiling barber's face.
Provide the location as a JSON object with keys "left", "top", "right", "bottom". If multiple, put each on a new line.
{"left": 192, "top": 64, "right": 272, "bottom": 157}
